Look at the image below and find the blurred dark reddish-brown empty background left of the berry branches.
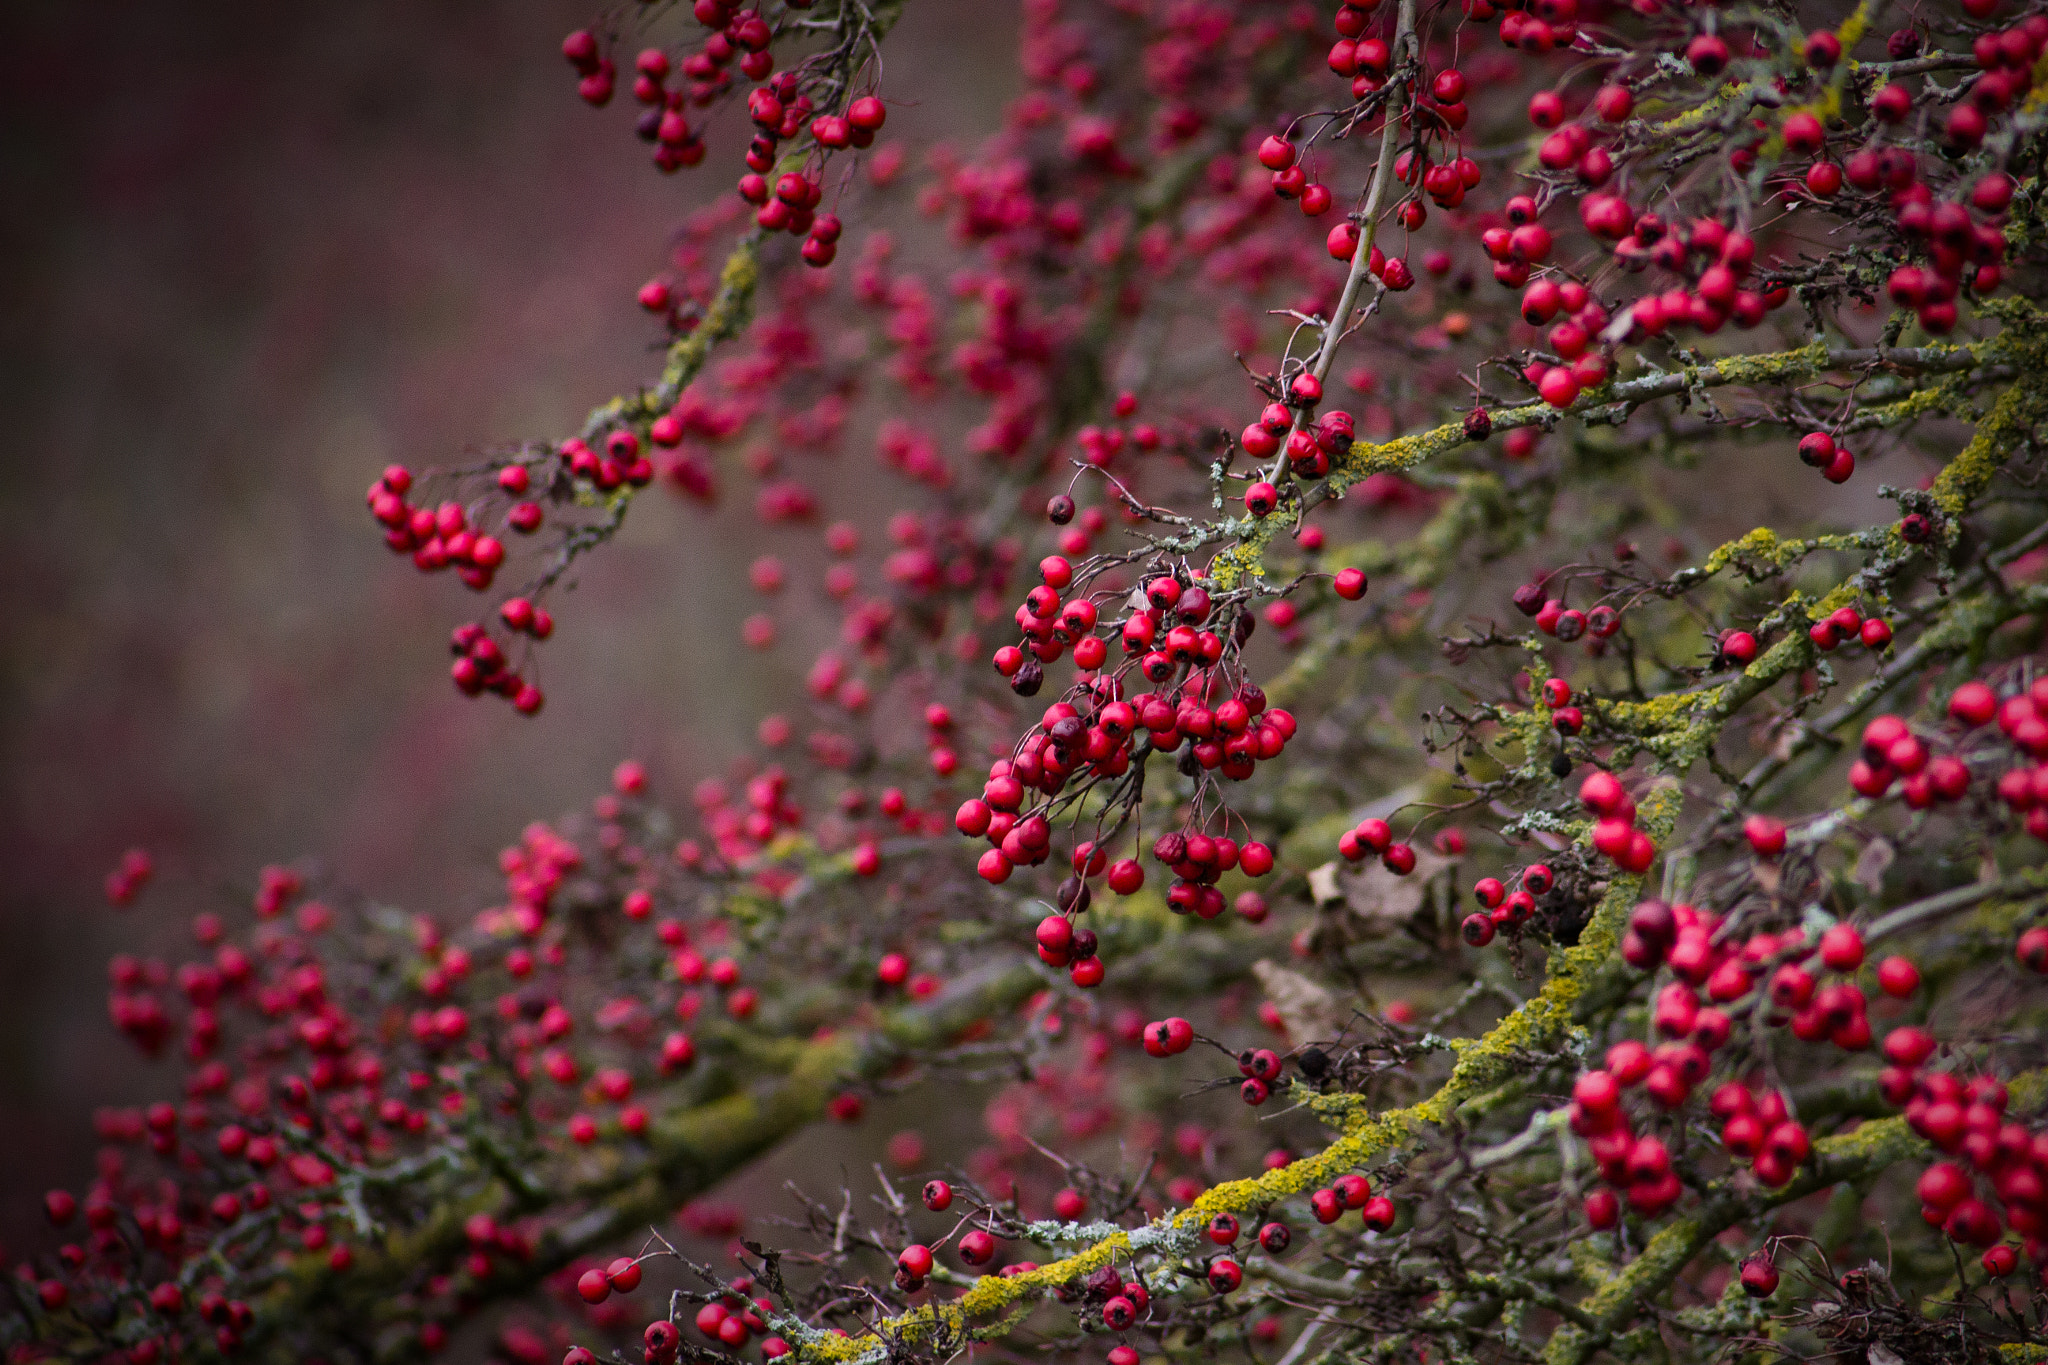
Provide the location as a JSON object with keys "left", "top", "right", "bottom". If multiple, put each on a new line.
{"left": 0, "top": 0, "right": 1018, "bottom": 1246}
